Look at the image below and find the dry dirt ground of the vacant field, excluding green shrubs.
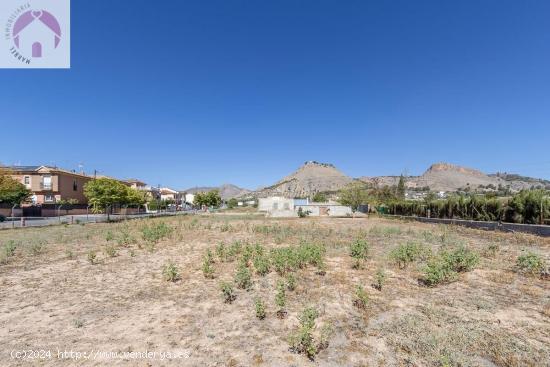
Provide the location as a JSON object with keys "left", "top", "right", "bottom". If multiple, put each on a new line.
{"left": 0, "top": 215, "right": 550, "bottom": 366}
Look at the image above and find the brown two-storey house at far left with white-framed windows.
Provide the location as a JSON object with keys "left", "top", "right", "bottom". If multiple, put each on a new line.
{"left": 6, "top": 166, "right": 93, "bottom": 204}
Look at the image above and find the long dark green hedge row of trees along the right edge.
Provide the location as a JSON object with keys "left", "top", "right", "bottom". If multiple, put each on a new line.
{"left": 339, "top": 183, "right": 550, "bottom": 224}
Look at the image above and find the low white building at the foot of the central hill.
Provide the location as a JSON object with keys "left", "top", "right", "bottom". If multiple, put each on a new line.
{"left": 258, "top": 196, "right": 352, "bottom": 217}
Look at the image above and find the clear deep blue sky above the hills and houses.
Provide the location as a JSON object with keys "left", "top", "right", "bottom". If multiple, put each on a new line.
{"left": 0, "top": 0, "right": 550, "bottom": 189}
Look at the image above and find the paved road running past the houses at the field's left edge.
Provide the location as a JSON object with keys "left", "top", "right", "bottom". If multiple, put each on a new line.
{"left": 0, "top": 210, "right": 196, "bottom": 229}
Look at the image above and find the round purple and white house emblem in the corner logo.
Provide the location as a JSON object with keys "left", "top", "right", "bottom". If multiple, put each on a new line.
{"left": 12, "top": 10, "right": 61, "bottom": 58}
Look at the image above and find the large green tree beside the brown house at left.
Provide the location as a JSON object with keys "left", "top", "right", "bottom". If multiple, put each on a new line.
{"left": 84, "top": 178, "right": 145, "bottom": 214}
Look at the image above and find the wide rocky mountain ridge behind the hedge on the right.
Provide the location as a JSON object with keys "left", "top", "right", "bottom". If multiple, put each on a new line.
{"left": 360, "top": 163, "right": 550, "bottom": 192}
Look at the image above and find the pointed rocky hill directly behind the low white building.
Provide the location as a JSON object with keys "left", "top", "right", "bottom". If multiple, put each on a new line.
{"left": 252, "top": 161, "right": 353, "bottom": 197}
